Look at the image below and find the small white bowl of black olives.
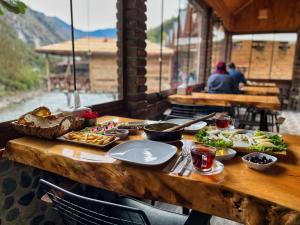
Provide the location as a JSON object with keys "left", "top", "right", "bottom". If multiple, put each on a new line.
{"left": 242, "top": 152, "right": 277, "bottom": 171}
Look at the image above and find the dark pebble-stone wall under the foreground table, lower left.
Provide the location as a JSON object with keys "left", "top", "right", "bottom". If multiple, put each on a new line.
{"left": 0, "top": 159, "right": 63, "bottom": 225}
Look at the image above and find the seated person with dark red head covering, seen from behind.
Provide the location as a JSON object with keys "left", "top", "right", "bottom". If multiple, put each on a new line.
{"left": 207, "top": 62, "right": 237, "bottom": 94}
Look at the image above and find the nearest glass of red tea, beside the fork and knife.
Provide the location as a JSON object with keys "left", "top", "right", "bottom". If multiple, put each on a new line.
{"left": 191, "top": 144, "right": 216, "bottom": 172}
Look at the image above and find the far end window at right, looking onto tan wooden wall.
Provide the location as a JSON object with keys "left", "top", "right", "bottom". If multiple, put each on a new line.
{"left": 231, "top": 33, "right": 297, "bottom": 80}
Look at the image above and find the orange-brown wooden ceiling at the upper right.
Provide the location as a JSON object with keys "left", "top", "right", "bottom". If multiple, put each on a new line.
{"left": 204, "top": 0, "right": 300, "bottom": 33}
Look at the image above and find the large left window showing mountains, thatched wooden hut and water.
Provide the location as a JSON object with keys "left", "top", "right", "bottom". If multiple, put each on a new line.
{"left": 0, "top": 0, "right": 121, "bottom": 121}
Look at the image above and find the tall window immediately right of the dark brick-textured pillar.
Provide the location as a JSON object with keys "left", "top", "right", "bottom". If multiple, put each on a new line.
{"left": 146, "top": 0, "right": 202, "bottom": 93}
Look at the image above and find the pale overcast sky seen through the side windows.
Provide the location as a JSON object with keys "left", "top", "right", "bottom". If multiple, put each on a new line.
{"left": 23, "top": 0, "right": 180, "bottom": 30}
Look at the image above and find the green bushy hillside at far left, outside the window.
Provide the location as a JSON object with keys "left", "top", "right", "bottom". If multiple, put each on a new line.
{"left": 0, "top": 18, "right": 43, "bottom": 96}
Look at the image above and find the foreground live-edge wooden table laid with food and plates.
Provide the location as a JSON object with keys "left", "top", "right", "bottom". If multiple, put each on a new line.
{"left": 3, "top": 116, "right": 300, "bottom": 225}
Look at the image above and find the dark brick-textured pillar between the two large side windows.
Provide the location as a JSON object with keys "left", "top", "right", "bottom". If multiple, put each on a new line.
{"left": 117, "top": 0, "right": 148, "bottom": 118}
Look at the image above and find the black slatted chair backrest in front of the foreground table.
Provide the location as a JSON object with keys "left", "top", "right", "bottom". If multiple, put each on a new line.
{"left": 40, "top": 179, "right": 151, "bottom": 225}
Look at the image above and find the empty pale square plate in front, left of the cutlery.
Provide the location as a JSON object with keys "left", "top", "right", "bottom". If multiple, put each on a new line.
{"left": 108, "top": 140, "right": 177, "bottom": 166}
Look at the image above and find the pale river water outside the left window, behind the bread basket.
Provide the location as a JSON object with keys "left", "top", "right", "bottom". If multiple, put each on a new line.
{"left": 0, "top": 92, "right": 116, "bottom": 122}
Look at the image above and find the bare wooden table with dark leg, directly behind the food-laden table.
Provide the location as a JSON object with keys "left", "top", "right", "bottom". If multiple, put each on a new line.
{"left": 169, "top": 92, "right": 280, "bottom": 131}
